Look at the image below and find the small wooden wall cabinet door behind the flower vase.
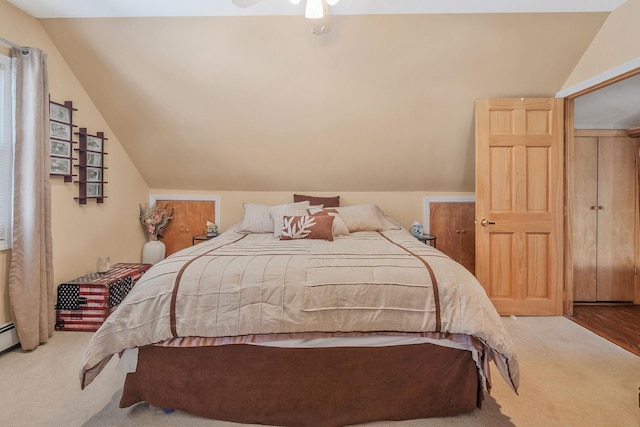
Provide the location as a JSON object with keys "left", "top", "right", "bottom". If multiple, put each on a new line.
{"left": 156, "top": 199, "right": 216, "bottom": 256}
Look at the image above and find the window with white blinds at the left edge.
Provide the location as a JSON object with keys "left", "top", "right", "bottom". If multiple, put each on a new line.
{"left": 0, "top": 55, "right": 13, "bottom": 250}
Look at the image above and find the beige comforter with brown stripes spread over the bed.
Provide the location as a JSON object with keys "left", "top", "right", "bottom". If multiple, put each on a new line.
{"left": 80, "top": 229, "right": 519, "bottom": 390}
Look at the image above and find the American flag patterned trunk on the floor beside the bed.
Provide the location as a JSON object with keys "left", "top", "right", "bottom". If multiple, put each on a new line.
{"left": 56, "top": 263, "right": 151, "bottom": 332}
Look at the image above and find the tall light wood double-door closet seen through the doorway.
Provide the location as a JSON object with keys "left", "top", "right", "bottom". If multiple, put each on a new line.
{"left": 572, "top": 130, "right": 638, "bottom": 302}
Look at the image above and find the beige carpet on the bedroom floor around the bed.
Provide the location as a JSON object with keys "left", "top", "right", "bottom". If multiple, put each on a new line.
{"left": 0, "top": 317, "right": 640, "bottom": 427}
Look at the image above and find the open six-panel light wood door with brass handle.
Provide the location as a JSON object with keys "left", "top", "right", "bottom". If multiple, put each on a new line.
{"left": 476, "top": 99, "right": 563, "bottom": 315}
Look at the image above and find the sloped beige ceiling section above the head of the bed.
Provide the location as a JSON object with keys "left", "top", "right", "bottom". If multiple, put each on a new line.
{"left": 8, "top": 2, "right": 620, "bottom": 191}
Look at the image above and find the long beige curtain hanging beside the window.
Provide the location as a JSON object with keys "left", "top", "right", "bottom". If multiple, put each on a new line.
{"left": 9, "top": 48, "right": 55, "bottom": 350}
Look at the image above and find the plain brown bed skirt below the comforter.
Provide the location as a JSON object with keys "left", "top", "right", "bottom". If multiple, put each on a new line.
{"left": 120, "top": 344, "right": 483, "bottom": 426}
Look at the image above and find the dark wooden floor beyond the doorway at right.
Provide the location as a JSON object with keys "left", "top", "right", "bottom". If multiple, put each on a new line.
{"left": 567, "top": 304, "right": 640, "bottom": 356}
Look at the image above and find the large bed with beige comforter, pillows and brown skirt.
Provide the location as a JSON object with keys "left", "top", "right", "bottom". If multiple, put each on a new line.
{"left": 80, "top": 201, "right": 519, "bottom": 426}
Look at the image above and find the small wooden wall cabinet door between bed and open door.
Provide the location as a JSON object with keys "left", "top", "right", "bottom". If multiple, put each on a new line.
{"left": 429, "top": 202, "right": 476, "bottom": 273}
